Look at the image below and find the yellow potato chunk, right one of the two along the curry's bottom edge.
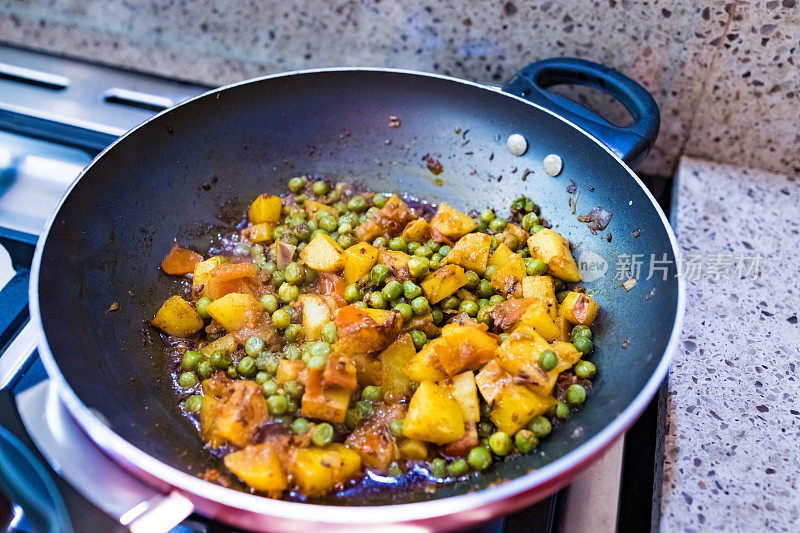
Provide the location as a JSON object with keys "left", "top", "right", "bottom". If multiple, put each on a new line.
{"left": 289, "top": 443, "right": 361, "bottom": 496}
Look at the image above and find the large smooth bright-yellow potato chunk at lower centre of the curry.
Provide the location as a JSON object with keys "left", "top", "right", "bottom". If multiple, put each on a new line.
{"left": 403, "top": 381, "right": 464, "bottom": 444}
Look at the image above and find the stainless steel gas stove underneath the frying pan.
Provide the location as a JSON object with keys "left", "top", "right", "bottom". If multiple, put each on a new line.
{"left": 0, "top": 46, "right": 667, "bottom": 533}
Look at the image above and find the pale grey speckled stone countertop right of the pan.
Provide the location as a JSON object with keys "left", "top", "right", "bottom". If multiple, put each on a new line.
{"left": 653, "top": 158, "right": 800, "bottom": 531}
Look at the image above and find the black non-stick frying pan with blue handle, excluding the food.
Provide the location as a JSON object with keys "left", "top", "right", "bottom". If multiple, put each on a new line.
{"left": 30, "top": 60, "right": 683, "bottom": 529}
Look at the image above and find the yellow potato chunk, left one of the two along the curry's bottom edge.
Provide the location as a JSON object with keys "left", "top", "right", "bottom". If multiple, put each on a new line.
{"left": 225, "top": 442, "right": 289, "bottom": 497}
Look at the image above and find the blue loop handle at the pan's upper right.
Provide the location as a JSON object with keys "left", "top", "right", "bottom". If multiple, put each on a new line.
{"left": 503, "top": 57, "right": 661, "bottom": 166}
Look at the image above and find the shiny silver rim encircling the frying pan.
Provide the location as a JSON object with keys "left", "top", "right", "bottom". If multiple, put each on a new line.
{"left": 29, "top": 67, "right": 686, "bottom": 525}
